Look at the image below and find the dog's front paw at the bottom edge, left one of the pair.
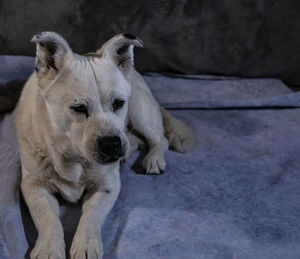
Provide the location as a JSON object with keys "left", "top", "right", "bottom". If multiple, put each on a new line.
{"left": 30, "top": 235, "right": 66, "bottom": 259}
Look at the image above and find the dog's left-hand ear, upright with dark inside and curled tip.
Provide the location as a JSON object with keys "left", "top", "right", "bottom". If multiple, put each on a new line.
{"left": 31, "top": 32, "right": 72, "bottom": 78}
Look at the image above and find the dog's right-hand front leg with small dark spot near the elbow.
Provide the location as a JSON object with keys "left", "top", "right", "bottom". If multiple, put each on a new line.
{"left": 70, "top": 171, "right": 120, "bottom": 259}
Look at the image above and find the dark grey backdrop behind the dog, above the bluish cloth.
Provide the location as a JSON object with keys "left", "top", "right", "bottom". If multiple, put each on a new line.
{"left": 0, "top": 0, "right": 300, "bottom": 86}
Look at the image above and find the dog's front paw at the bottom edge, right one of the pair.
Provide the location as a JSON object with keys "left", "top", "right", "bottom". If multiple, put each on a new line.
{"left": 70, "top": 233, "right": 103, "bottom": 259}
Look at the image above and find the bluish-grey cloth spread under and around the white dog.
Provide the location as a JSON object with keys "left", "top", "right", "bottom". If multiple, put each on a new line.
{"left": 0, "top": 55, "right": 300, "bottom": 259}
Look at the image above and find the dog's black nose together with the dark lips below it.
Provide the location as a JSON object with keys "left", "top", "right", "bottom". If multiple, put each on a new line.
{"left": 98, "top": 136, "right": 126, "bottom": 164}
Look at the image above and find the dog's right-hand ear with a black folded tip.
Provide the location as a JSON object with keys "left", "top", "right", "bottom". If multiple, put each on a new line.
{"left": 96, "top": 33, "right": 143, "bottom": 74}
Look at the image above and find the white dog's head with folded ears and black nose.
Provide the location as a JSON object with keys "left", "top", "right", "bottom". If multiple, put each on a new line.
{"left": 32, "top": 32, "right": 142, "bottom": 164}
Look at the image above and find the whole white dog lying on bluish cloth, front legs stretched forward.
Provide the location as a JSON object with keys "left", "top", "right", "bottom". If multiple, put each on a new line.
{"left": 15, "top": 32, "right": 194, "bottom": 259}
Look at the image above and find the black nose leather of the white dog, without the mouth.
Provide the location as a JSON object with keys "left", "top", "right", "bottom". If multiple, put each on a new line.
{"left": 99, "top": 136, "right": 124, "bottom": 157}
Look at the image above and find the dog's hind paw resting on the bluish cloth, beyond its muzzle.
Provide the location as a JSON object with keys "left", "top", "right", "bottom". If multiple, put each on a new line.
{"left": 143, "top": 150, "right": 166, "bottom": 174}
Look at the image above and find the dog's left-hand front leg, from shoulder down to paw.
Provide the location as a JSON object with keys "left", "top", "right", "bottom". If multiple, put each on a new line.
{"left": 21, "top": 176, "right": 66, "bottom": 259}
